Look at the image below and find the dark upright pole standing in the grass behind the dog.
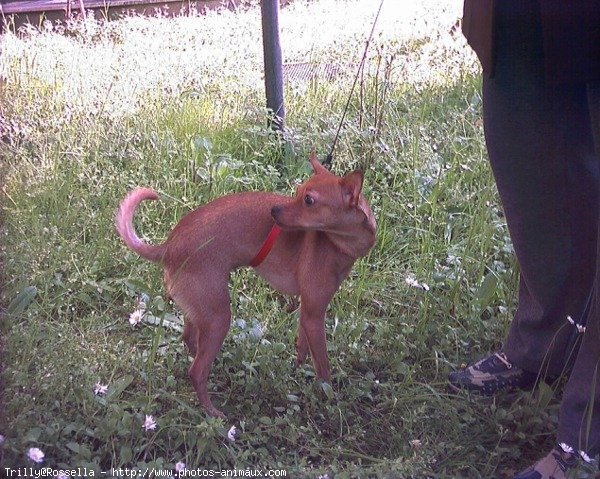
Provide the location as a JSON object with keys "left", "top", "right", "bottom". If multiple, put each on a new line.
{"left": 261, "top": 0, "right": 285, "bottom": 130}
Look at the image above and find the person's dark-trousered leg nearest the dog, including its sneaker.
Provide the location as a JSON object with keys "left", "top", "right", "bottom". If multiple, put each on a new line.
{"left": 450, "top": 0, "right": 598, "bottom": 393}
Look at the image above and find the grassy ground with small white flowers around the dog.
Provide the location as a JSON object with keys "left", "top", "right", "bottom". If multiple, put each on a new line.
{"left": 0, "top": 0, "right": 584, "bottom": 478}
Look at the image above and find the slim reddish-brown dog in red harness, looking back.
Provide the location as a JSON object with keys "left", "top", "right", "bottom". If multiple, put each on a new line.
{"left": 116, "top": 154, "right": 375, "bottom": 417}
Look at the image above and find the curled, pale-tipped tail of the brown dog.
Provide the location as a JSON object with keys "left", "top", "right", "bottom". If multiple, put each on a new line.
{"left": 115, "top": 188, "right": 165, "bottom": 263}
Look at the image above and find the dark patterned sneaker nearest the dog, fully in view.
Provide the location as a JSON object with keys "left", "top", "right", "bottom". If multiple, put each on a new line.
{"left": 448, "top": 352, "right": 537, "bottom": 396}
